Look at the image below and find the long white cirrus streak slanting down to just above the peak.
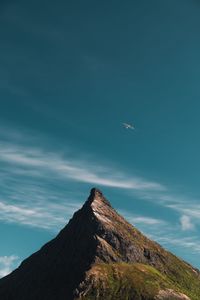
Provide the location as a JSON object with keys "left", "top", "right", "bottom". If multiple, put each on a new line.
{"left": 0, "top": 145, "right": 165, "bottom": 191}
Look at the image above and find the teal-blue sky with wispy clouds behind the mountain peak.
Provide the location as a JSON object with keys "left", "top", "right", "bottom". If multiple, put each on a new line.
{"left": 0, "top": 0, "right": 200, "bottom": 277}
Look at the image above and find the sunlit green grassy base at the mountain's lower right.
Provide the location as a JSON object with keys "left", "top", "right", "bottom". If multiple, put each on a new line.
{"left": 79, "top": 263, "right": 200, "bottom": 300}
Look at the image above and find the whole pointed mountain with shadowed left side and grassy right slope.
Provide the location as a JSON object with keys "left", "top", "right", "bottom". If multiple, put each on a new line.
{"left": 0, "top": 188, "right": 200, "bottom": 300}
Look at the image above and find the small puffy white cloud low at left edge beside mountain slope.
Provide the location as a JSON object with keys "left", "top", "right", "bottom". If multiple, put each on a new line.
{"left": 0, "top": 255, "right": 19, "bottom": 278}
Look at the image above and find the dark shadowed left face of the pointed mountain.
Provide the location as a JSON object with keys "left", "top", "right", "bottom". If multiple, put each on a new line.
{"left": 0, "top": 189, "right": 98, "bottom": 300}
